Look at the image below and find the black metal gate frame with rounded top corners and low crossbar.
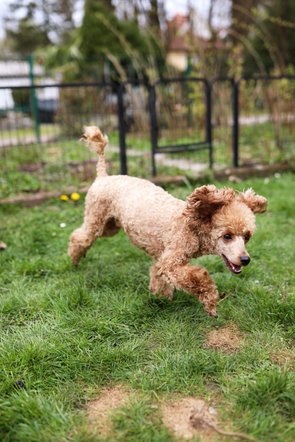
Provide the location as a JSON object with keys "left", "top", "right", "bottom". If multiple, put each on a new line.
{"left": 149, "top": 78, "right": 213, "bottom": 175}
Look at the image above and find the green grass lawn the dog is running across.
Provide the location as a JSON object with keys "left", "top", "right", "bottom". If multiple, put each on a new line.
{"left": 0, "top": 174, "right": 295, "bottom": 442}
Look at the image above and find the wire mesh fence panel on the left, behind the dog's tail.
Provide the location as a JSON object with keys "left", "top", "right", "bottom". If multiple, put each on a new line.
{"left": 0, "top": 83, "right": 120, "bottom": 197}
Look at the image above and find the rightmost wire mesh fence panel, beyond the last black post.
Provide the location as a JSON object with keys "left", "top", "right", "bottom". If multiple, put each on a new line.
{"left": 239, "top": 77, "right": 295, "bottom": 165}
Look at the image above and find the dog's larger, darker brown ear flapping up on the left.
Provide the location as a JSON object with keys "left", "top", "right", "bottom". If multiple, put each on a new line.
{"left": 185, "top": 185, "right": 235, "bottom": 221}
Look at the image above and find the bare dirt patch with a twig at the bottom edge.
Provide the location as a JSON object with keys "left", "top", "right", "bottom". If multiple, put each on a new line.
{"left": 161, "top": 397, "right": 217, "bottom": 441}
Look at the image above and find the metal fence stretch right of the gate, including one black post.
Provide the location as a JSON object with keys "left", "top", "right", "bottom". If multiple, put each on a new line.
{"left": 211, "top": 75, "right": 295, "bottom": 167}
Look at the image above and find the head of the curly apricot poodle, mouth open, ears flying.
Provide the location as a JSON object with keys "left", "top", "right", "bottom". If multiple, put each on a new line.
{"left": 185, "top": 185, "right": 267, "bottom": 273}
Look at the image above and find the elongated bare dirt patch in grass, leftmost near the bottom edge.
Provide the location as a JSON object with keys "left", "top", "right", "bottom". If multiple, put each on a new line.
{"left": 87, "top": 385, "right": 132, "bottom": 437}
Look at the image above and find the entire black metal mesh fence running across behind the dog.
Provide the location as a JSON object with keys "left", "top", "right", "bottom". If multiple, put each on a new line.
{"left": 0, "top": 75, "right": 295, "bottom": 196}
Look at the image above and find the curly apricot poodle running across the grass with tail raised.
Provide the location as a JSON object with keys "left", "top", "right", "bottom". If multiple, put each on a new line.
{"left": 69, "top": 126, "right": 267, "bottom": 316}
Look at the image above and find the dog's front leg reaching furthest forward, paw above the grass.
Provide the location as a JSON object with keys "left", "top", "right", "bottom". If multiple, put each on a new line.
{"left": 157, "top": 262, "right": 218, "bottom": 317}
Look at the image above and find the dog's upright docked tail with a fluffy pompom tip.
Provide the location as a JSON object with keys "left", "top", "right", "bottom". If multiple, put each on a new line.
{"left": 80, "top": 126, "right": 109, "bottom": 176}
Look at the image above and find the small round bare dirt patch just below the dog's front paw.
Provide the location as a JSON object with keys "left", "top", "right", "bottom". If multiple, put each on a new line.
{"left": 205, "top": 325, "right": 243, "bottom": 353}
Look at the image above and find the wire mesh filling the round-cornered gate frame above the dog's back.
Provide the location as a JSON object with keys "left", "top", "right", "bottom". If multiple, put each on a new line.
{"left": 150, "top": 78, "right": 212, "bottom": 174}
